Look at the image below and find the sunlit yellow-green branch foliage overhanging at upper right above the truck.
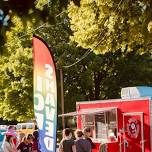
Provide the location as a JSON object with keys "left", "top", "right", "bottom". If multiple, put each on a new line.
{"left": 68, "top": 0, "right": 152, "bottom": 53}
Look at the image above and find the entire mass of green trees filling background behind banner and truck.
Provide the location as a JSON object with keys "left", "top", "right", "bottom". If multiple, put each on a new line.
{"left": 0, "top": 0, "right": 152, "bottom": 121}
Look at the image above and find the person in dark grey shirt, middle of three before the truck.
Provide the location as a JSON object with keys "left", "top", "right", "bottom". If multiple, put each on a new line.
{"left": 75, "top": 130, "right": 91, "bottom": 152}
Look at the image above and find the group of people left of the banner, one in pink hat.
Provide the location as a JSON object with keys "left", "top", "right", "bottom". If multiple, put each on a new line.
{"left": 2, "top": 126, "right": 40, "bottom": 152}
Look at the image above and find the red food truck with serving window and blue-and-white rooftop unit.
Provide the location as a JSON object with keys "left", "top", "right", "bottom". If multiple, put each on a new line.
{"left": 60, "top": 87, "right": 152, "bottom": 152}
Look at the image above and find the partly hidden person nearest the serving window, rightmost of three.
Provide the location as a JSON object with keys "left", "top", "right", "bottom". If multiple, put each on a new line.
{"left": 83, "top": 127, "right": 96, "bottom": 149}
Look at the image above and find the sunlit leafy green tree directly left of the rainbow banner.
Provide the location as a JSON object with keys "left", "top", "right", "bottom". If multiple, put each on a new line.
{"left": 0, "top": 15, "right": 41, "bottom": 121}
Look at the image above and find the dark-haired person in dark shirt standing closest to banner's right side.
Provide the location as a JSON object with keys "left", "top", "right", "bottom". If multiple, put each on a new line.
{"left": 59, "top": 128, "right": 76, "bottom": 152}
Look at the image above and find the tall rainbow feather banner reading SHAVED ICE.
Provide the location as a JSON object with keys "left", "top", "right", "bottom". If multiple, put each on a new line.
{"left": 33, "top": 36, "right": 57, "bottom": 152}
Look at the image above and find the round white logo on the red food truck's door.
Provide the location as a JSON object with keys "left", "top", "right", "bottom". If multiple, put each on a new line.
{"left": 127, "top": 118, "right": 140, "bottom": 138}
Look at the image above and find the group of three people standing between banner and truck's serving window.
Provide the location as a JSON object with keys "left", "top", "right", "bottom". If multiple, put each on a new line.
{"left": 59, "top": 127, "right": 95, "bottom": 152}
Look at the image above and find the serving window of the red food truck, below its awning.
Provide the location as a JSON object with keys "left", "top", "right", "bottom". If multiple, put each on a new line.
{"left": 82, "top": 109, "right": 117, "bottom": 142}
